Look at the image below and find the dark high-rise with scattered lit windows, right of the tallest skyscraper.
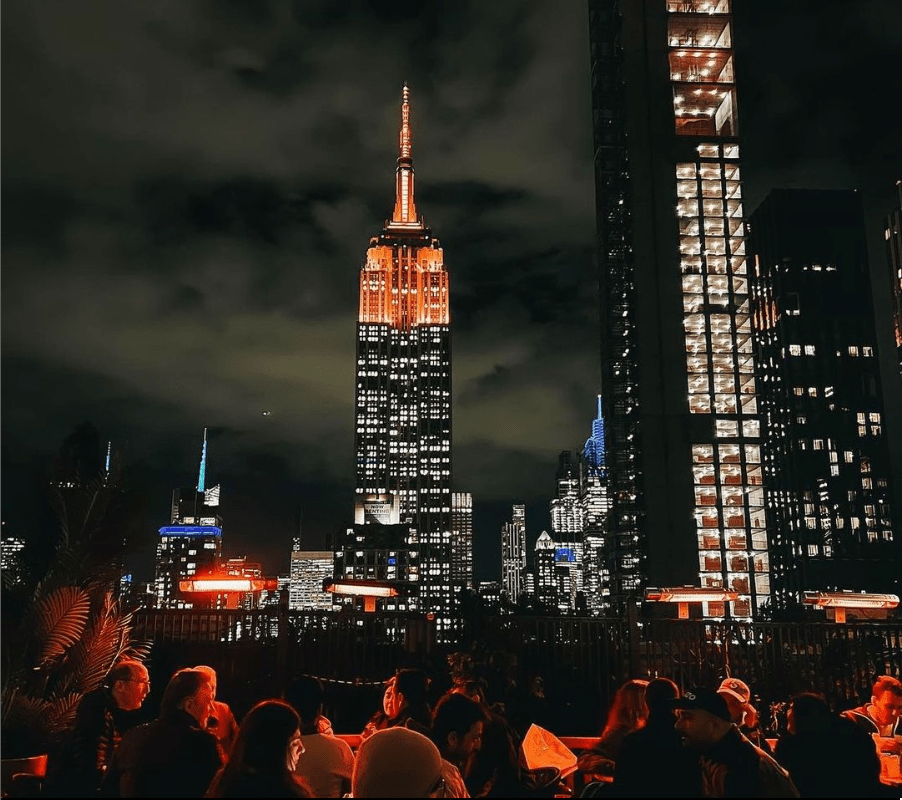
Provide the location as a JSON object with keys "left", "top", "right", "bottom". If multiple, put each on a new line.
{"left": 748, "top": 189, "right": 902, "bottom": 608}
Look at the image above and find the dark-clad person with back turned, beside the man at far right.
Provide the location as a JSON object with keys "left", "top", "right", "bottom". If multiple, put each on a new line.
{"left": 775, "top": 692, "right": 882, "bottom": 797}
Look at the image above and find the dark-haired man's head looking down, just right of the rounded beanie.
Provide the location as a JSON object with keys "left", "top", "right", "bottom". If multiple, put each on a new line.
{"left": 432, "top": 692, "right": 486, "bottom": 797}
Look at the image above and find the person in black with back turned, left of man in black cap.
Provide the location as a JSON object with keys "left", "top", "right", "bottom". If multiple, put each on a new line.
{"left": 613, "top": 678, "right": 702, "bottom": 797}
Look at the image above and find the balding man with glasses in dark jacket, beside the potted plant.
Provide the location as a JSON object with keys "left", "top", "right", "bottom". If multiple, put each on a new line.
{"left": 61, "top": 658, "right": 150, "bottom": 797}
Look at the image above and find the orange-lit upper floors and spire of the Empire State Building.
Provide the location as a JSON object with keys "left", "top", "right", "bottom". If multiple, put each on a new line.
{"left": 357, "top": 84, "right": 449, "bottom": 330}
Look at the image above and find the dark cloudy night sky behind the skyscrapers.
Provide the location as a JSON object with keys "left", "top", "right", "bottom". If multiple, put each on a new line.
{"left": 2, "top": 0, "right": 902, "bottom": 579}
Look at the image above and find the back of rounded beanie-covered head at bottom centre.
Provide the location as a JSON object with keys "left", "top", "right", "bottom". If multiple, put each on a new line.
{"left": 351, "top": 727, "right": 442, "bottom": 797}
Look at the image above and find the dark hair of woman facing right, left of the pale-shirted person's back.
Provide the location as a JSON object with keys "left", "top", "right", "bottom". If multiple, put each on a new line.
{"left": 229, "top": 700, "right": 301, "bottom": 774}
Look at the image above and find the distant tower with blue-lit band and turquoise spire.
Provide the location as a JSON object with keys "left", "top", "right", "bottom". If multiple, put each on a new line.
{"left": 153, "top": 428, "right": 222, "bottom": 609}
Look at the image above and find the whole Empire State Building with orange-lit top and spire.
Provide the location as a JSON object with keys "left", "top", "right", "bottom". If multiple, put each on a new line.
{"left": 355, "top": 85, "right": 452, "bottom": 611}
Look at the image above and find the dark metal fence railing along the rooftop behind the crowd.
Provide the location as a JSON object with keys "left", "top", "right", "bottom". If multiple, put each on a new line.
{"left": 134, "top": 607, "right": 902, "bottom": 735}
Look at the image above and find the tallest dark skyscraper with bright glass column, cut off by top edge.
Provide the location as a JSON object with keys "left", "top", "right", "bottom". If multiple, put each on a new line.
{"left": 589, "top": 0, "right": 770, "bottom": 617}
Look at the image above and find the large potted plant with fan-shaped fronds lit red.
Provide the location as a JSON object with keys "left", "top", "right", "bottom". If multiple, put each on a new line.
{"left": 2, "top": 428, "right": 150, "bottom": 788}
